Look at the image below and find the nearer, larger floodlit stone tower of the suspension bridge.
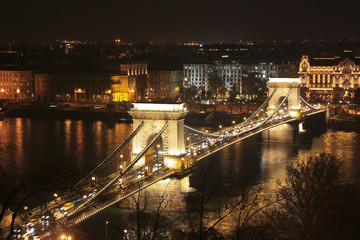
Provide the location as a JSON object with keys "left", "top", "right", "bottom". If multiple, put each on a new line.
{"left": 129, "top": 103, "right": 187, "bottom": 171}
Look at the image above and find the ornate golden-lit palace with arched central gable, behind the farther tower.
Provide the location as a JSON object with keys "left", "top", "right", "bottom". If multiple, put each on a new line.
{"left": 299, "top": 50, "right": 360, "bottom": 102}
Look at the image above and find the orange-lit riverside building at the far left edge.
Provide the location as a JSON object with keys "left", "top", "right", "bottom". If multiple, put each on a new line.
{"left": 0, "top": 70, "right": 33, "bottom": 101}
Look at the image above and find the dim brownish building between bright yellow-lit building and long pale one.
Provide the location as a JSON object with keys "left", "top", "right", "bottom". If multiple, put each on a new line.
{"left": 148, "top": 71, "right": 183, "bottom": 99}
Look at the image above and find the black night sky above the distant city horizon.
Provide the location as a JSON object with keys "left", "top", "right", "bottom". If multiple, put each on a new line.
{"left": 0, "top": 0, "right": 360, "bottom": 43}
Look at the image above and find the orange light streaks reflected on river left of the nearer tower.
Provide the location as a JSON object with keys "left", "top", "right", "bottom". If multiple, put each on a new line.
{"left": 0, "top": 118, "right": 132, "bottom": 175}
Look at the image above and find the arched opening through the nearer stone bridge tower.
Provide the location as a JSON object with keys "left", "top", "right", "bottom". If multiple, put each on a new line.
{"left": 145, "top": 134, "right": 164, "bottom": 171}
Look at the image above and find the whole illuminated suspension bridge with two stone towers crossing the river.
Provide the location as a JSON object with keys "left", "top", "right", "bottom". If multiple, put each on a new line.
{"left": 17, "top": 78, "right": 326, "bottom": 238}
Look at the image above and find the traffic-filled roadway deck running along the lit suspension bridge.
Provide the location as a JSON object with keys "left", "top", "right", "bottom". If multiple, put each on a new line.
{"left": 17, "top": 109, "right": 325, "bottom": 238}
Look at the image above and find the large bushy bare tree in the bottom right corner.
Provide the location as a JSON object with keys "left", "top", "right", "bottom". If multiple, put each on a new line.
{"left": 266, "top": 154, "right": 360, "bottom": 240}
